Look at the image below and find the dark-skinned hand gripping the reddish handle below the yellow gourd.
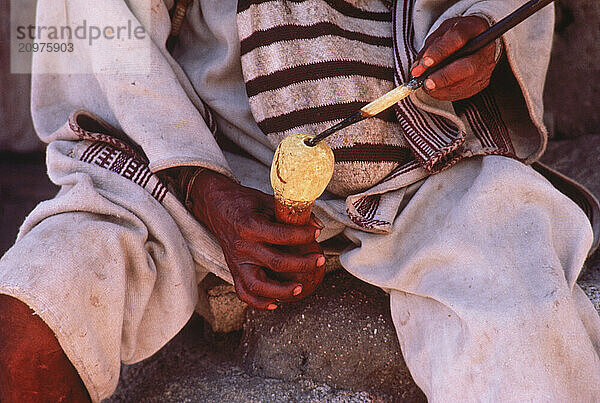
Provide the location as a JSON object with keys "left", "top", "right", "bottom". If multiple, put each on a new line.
{"left": 190, "top": 170, "right": 325, "bottom": 310}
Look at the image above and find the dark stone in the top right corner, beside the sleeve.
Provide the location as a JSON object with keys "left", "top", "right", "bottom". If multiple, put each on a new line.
{"left": 544, "top": 0, "right": 600, "bottom": 139}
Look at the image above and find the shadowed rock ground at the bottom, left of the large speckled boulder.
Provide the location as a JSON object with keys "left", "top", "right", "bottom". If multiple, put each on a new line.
{"left": 104, "top": 316, "right": 385, "bottom": 403}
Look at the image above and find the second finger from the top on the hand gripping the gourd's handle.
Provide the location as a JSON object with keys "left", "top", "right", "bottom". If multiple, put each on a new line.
{"left": 235, "top": 242, "right": 325, "bottom": 273}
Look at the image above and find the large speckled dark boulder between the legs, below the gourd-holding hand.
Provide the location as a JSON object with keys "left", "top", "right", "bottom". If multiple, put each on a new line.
{"left": 240, "top": 270, "right": 425, "bottom": 401}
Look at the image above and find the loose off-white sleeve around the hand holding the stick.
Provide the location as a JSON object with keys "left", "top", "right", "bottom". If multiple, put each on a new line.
{"left": 396, "top": 0, "right": 554, "bottom": 167}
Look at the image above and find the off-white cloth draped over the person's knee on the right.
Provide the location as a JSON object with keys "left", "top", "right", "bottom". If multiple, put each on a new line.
{"left": 340, "top": 156, "right": 600, "bottom": 401}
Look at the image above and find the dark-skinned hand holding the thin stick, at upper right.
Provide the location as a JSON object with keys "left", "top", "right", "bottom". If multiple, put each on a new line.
{"left": 411, "top": 16, "right": 496, "bottom": 101}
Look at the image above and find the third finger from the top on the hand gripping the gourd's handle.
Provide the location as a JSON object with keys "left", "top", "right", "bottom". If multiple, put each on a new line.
{"left": 240, "top": 265, "right": 302, "bottom": 300}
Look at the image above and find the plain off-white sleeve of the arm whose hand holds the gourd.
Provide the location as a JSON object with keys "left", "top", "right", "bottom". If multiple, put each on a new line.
{"left": 32, "top": 0, "right": 233, "bottom": 178}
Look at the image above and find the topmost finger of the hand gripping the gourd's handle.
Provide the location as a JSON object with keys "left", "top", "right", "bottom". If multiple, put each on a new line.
{"left": 241, "top": 215, "right": 321, "bottom": 245}
